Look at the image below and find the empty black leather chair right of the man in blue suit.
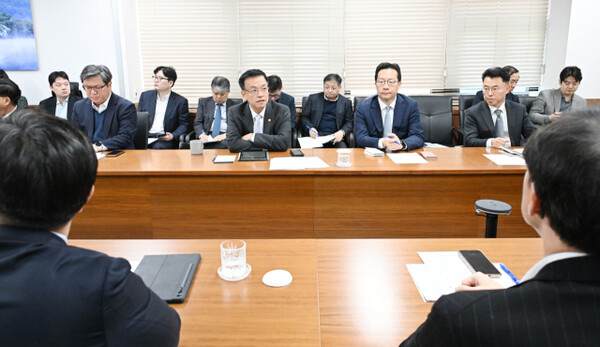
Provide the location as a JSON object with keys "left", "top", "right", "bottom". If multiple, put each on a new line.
{"left": 411, "top": 95, "right": 452, "bottom": 146}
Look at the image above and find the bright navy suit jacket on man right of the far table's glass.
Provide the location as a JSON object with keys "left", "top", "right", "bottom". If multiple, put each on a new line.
{"left": 354, "top": 94, "right": 424, "bottom": 151}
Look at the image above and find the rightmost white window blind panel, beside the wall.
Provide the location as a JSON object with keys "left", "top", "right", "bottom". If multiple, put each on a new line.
{"left": 445, "top": 0, "right": 548, "bottom": 88}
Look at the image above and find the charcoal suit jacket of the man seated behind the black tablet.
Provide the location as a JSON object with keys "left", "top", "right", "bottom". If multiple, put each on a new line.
{"left": 227, "top": 101, "right": 292, "bottom": 152}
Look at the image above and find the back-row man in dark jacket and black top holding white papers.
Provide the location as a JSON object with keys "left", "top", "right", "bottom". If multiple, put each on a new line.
{"left": 301, "top": 74, "right": 354, "bottom": 148}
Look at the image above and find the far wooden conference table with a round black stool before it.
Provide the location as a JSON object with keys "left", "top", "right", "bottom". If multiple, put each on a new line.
{"left": 72, "top": 147, "right": 536, "bottom": 239}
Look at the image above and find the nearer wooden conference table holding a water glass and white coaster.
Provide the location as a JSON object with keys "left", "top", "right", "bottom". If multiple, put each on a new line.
{"left": 69, "top": 238, "right": 543, "bottom": 346}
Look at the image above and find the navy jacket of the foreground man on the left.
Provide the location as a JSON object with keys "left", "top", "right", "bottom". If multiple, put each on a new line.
{"left": 0, "top": 226, "right": 181, "bottom": 346}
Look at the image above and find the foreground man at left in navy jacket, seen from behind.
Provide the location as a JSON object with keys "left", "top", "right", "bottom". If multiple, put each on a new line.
{"left": 0, "top": 109, "right": 181, "bottom": 346}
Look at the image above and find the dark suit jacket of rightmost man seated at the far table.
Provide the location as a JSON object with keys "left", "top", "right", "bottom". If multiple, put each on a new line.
{"left": 465, "top": 101, "right": 535, "bottom": 147}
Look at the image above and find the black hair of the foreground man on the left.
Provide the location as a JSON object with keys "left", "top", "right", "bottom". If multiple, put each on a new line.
{"left": 0, "top": 109, "right": 98, "bottom": 231}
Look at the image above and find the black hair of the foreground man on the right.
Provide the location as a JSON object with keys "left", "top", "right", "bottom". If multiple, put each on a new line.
{"left": 524, "top": 109, "right": 600, "bottom": 255}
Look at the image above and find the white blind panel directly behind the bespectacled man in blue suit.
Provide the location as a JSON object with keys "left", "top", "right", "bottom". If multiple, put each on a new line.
{"left": 344, "top": 0, "right": 449, "bottom": 95}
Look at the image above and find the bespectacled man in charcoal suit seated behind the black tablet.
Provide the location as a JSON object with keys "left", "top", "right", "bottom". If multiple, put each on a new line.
{"left": 227, "top": 69, "right": 291, "bottom": 152}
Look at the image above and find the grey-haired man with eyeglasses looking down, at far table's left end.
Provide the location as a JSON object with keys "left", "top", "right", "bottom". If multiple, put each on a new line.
{"left": 71, "top": 65, "right": 137, "bottom": 152}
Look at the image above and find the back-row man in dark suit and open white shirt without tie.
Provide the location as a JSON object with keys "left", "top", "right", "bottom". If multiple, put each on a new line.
{"left": 138, "top": 66, "right": 190, "bottom": 149}
